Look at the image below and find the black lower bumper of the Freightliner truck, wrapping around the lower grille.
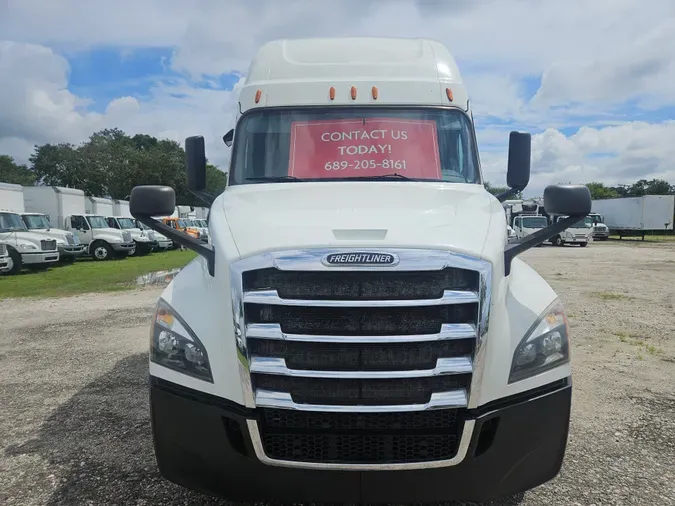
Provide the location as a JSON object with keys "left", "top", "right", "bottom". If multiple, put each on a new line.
{"left": 150, "top": 378, "right": 572, "bottom": 503}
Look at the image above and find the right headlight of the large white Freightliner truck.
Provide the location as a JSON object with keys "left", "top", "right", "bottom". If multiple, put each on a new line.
{"left": 509, "top": 300, "right": 570, "bottom": 383}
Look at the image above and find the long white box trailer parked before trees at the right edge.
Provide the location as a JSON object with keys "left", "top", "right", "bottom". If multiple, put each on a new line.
{"left": 593, "top": 195, "right": 675, "bottom": 240}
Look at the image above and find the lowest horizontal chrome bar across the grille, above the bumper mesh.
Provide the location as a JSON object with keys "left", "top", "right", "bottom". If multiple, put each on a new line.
{"left": 256, "top": 389, "right": 467, "bottom": 413}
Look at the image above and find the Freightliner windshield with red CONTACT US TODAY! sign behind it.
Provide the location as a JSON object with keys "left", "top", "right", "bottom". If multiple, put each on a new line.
{"left": 230, "top": 106, "right": 480, "bottom": 185}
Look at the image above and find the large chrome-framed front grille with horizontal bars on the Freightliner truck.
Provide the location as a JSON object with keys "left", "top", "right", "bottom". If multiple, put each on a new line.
{"left": 231, "top": 250, "right": 490, "bottom": 469}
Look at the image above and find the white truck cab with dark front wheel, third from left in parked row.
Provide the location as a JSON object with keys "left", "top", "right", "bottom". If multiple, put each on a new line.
{"left": 65, "top": 214, "right": 136, "bottom": 260}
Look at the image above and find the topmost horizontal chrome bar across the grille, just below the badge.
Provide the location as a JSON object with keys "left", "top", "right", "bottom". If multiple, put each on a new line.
{"left": 244, "top": 290, "right": 478, "bottom": 307}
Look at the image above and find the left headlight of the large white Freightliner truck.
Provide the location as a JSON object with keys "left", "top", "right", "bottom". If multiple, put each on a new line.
{"left": 150, "top": 300, "right": 213, "bottom": 383}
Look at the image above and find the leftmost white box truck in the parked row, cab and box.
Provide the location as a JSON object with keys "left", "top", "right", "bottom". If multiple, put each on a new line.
{"left": 0, "top": 183, "right": 59, "bottom": 274}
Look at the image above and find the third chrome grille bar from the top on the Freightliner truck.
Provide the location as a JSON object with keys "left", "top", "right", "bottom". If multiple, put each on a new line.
{"left": 251, "top": 357, "right": 473, "bottom": 379}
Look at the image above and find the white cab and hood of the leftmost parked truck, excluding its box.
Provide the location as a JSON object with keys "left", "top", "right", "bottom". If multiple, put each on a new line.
{"left": 0, "top": 210, "right": 59, "bottom": 274}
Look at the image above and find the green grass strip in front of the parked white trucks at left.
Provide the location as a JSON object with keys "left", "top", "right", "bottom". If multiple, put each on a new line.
{"left": 0, "top": 250, "right": 196, "bottom": 300}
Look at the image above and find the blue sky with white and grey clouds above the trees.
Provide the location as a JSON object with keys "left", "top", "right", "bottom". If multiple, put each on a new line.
{"left": 0, "top": 0, "right": 675, "bottom": 196}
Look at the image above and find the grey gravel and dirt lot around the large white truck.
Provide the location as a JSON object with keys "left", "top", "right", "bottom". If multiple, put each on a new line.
{"left": 0, "top": 243, "right": 675, "bottom": 506}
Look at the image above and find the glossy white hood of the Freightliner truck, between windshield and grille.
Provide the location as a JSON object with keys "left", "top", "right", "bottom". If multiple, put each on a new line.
{"left": 218, "top": 181, "right": 496, "bottom": 257}
